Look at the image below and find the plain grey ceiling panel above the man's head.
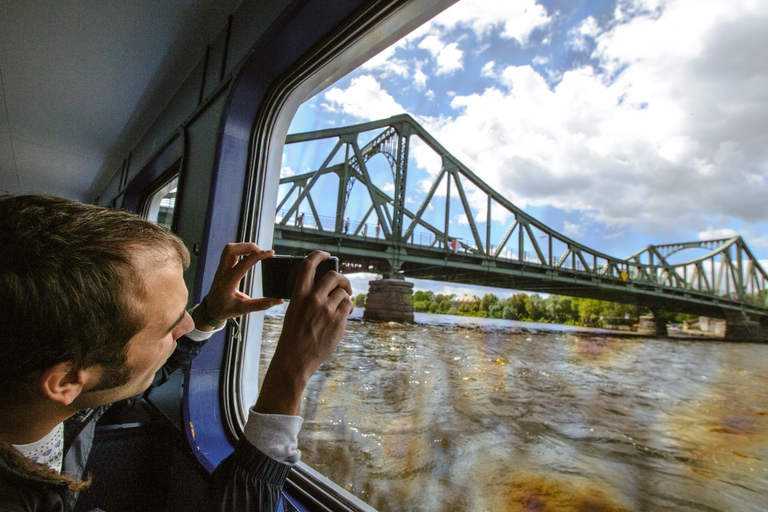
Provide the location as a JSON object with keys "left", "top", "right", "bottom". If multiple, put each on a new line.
{"left": 0, "top": 0, "right": 239, "bottom": 200}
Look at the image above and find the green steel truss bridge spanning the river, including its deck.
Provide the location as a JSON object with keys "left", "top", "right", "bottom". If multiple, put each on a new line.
{"left": 273, "top": 115, "right": 768, "bottom": 325}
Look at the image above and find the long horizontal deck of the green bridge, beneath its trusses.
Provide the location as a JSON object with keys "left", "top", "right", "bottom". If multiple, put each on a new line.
{"left": 273, "top": 226, "right": 764, "bottom": 320}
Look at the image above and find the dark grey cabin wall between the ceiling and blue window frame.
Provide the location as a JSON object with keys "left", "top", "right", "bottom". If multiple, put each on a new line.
{"left": 97, "top": 0, "right": 296, "bottom": 425}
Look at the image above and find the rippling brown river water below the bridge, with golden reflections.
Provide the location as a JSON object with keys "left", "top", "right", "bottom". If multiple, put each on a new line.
{"left": 261, "top": 310, "right": 768, "bottom": 512}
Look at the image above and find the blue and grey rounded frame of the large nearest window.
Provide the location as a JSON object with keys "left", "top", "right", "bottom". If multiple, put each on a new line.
{"left": 187, "top": 0, "right": 457, "bottom": 511}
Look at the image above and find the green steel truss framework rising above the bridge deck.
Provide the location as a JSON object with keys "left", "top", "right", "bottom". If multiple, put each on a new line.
{"left": 277, "top": 115, "right": 768, "bottom": 309}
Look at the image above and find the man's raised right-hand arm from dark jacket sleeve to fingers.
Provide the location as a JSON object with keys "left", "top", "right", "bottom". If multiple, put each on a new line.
{"left": 207, "top": 251, "right": 353, "bottom": 511}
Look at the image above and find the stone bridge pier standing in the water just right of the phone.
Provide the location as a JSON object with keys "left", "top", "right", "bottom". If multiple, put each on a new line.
{"left": 363, "top": 279, "right": 413, "bottom": 323}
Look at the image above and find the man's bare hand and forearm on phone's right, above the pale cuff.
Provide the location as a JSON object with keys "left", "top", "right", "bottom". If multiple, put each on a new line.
{"left": 256, "top": 251, "right": 354, "bottom": 415}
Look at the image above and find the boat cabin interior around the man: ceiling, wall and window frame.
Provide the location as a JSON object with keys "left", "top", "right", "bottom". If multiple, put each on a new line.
{"left": 0, "top": 0, "right": 453, "bottom": 512}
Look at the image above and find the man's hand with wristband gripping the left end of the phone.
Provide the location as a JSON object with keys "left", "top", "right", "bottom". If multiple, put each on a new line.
{"left": 192, "top": 243, "right": 283, "bottom": 331}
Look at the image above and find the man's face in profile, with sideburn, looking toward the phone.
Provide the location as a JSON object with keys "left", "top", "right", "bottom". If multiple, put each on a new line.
{"left": 80, "top": 252, "right": 195, "bottom": 407}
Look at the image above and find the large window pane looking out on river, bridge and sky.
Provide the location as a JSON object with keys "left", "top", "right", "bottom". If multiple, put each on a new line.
{"left": 252, "top": 0, "right": 768, "bottom": 511}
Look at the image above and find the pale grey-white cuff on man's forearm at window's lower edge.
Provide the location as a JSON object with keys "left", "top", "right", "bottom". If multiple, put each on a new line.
{"left": 243, "top": 407, "right": 304, "bottom": 466}
